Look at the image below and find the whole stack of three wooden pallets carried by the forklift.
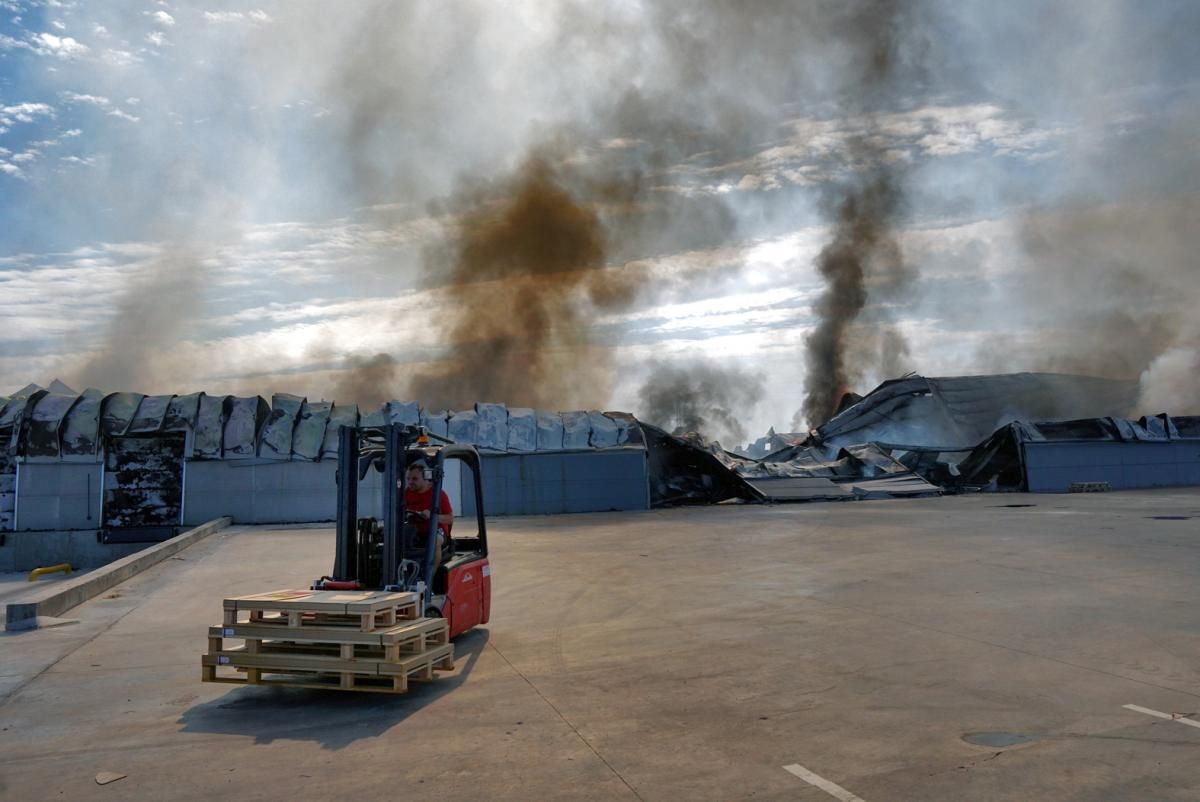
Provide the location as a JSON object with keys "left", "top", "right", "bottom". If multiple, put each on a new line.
{"left": 202, "top": 591, "right": 454, "bottom": 693}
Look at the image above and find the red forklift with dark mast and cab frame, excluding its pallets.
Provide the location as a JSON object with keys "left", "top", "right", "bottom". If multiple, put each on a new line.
{"left": 312, "top": 424, "right": 492, "bottom": 638}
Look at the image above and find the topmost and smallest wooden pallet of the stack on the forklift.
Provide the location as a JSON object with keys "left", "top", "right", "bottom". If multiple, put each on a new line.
{"left": 224, "top": 591, "right": 422, "bottom": 633}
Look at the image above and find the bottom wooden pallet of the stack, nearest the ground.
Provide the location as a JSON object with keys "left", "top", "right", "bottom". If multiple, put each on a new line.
{"left": 200, "top": 644, "right": 454, "bottom": 693}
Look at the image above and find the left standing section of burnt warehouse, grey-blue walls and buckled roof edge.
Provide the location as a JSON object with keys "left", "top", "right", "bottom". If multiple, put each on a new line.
{"left": 0, "top": 385, "right": 650, "bottom": 531}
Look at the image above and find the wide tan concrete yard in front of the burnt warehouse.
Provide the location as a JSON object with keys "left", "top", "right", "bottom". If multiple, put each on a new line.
{"left": 0, "top": 490, "right": 1200, "bottom": 802}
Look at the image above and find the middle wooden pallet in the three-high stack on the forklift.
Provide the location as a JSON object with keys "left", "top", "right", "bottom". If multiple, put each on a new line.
{"left": 209, "top": 618, "right": 450, "bottom": 662}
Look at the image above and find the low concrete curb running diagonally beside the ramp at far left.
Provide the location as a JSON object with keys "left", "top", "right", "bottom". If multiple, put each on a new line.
{"left": 5, "top": 516, "right": 233, "bottom": 632}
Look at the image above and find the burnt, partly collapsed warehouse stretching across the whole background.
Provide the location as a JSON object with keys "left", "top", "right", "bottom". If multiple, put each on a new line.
{"left": 0, "top": 373, "right": 1200, "bottom": 537}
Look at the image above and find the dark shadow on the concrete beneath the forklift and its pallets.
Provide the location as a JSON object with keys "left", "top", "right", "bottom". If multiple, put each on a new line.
{"left": 178, "top": 629, "right": 488, "bottom": 750}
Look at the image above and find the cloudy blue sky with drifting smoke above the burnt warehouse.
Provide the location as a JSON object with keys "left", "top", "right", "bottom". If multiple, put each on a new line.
{"left": 0, "top": 0, "right": 1200, "bottom": 439}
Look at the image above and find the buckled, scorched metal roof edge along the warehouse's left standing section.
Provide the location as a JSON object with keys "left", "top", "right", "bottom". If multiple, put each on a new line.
{"left": 0, "top": 385, "right": 644, "bottom": 461}
